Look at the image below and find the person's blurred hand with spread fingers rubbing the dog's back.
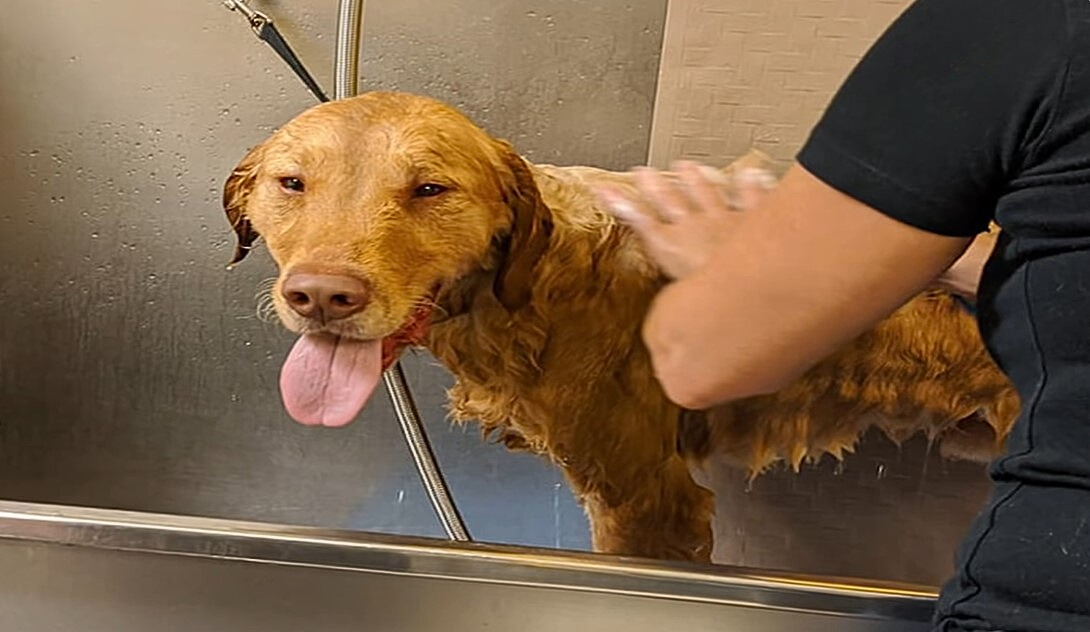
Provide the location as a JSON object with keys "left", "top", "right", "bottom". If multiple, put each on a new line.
{"left": 596, "top": 161, "right": 775, "bottom": 279}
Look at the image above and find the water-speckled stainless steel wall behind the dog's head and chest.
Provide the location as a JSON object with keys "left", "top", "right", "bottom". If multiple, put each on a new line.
{"left": 0, "top": 0, "right": 665, "bottom": 548}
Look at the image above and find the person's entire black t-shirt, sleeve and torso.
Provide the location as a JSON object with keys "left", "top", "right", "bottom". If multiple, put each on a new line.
{"left": 798, "top": 0, "right": 1090, "bottom": 632}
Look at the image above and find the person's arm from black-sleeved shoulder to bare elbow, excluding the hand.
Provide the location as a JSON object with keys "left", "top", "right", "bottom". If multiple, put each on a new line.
{"left": 627, "top": 0, "right": 1071, "bottom": 408}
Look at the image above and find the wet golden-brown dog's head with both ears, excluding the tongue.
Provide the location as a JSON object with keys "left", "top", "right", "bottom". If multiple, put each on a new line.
{"left": 223, "top": 93, "right": 550, "bottom": 340}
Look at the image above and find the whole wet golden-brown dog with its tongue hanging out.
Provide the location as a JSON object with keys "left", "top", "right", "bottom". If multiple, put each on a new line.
{"left": 225, "top": 93, "right": 1018, "bottom": 560}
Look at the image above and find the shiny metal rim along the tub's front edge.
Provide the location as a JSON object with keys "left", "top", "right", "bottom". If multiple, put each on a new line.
{"left": 0, "top": 501, "right": 935, "bottom": 623}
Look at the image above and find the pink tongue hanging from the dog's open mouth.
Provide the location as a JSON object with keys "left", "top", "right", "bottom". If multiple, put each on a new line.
{"left": 280, "top": 335, "right": 383, "bottom": 427}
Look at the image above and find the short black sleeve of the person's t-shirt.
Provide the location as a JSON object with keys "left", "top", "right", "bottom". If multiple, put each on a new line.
{"left": 798, "top": 0, "right": 1068, "bottom": 236}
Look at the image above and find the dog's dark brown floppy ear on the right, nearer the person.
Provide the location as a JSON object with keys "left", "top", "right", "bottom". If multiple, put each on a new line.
{"left": 493, "top": 142, "right": 553, "bottom": 312}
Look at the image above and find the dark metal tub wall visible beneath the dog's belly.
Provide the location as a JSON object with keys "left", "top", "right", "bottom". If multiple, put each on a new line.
{"left": 709, "top": 433, "right": 990, "bottom": 586}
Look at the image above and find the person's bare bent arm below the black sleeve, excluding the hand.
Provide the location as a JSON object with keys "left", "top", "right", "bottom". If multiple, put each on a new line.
{"left": 644, "top": 166, "right": 969, "bottom": 409}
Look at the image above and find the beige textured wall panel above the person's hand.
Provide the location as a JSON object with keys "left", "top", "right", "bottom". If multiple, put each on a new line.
{"left": 650, "top": 0, "right": 908, "bottom": 167}
